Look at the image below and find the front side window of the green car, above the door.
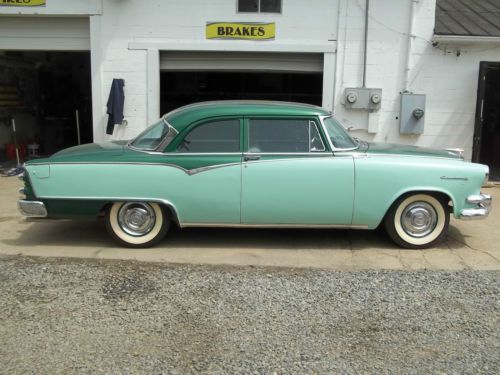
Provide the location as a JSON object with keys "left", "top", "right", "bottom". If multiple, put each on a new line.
{"left": 248, "top": 119, "right": 325, "bottom": 153}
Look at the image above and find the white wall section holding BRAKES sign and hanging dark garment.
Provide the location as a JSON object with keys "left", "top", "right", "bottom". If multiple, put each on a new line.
{"left": 91, "top": 0, "right": 337, "bottom": 140}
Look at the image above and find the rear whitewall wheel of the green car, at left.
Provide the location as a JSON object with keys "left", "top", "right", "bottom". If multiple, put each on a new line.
{"left": 106, "top": 202, "right": 170, "bottom": 248}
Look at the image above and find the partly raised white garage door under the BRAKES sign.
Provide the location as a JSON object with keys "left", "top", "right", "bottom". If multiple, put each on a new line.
{"left": 160, "top": 52, "right": 323, "bottom": 72}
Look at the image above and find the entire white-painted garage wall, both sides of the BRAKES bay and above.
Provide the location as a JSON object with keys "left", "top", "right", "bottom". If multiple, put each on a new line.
{"left": 0, "top": 0, "right": 500, "bottom": 159}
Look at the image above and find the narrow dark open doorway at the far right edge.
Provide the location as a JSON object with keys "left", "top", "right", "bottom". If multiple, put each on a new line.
{"left": 472, "top": 62, "right": 500, "bottom": 181}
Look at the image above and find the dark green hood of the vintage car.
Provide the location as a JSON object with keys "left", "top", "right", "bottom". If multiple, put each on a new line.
{"left": 366, "top": 142, "right": 463, "bottom": 160}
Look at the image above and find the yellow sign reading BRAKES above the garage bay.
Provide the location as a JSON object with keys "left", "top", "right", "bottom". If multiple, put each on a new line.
{"left": 206, "top": 22, "right": 276, "bottom": 40}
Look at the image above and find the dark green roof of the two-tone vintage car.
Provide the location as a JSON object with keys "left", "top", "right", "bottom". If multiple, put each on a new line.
{"left": 164, "top": 100, "right": 331, "bottom": 131}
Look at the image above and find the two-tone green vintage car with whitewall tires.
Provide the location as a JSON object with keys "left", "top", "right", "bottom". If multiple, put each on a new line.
{"left": 19, "top": 101, "right": 491, "bottom": 248}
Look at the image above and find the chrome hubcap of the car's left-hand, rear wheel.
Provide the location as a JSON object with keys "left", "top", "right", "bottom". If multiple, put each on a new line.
{"left": 118, "top": 202, "right": 156, "bottom": 237}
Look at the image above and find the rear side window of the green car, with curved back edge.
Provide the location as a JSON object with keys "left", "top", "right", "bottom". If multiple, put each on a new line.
{"left": 177, "top": 119, "right": 241, "bottom": 153}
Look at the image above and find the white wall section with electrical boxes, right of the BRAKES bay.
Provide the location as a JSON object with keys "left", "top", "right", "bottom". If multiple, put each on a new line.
{"left": 335, "top": 0, "right": 500, "bottom": 159}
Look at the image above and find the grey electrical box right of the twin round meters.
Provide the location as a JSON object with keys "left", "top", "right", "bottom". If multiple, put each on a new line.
{"left": 399, "top": 93, "right": 425, "bottom": 134}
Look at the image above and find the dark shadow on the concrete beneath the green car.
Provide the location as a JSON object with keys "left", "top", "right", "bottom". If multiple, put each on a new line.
{"left": 0, "top": 220, "right": 454, "bottom": 250}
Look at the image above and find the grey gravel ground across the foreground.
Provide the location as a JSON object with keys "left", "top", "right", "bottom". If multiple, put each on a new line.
{"left": 0, "top": 257, "right": 500, "bottom": 374}
